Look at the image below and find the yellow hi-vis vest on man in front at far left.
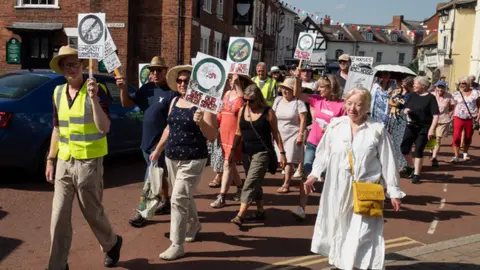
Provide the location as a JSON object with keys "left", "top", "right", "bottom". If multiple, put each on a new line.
{"left": 53, "top": 82, "right": 108, "bottom": 160}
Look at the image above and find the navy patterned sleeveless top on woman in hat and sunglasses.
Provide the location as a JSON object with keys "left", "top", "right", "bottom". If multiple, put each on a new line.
{"left": 165, "top": 98, "right": 208, "bottom": 160}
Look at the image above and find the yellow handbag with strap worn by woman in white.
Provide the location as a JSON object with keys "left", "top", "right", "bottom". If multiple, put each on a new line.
{"left": 347, "top": 150, "right": 385, "bottom": 217}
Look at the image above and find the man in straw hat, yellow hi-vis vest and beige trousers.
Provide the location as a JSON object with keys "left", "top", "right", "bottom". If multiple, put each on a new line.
{"left": 45, "top": 46, "right": 122, "bottom": 270}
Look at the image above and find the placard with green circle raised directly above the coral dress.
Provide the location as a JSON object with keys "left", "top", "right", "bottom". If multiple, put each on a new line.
{"left": 227, "top": 37, "right": 254, "bottom": 75}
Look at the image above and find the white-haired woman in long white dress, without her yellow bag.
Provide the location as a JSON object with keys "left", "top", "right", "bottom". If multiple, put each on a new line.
{"left": 304, "top": 88, "right": 405, "bottom": 270}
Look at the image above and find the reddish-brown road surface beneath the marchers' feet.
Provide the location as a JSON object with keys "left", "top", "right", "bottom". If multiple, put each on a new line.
{"left": 0, "top": 133, "right": 480, "bottom": 270}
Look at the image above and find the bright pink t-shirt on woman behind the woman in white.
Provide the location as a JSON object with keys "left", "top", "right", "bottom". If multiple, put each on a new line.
{"left": 307, "top": 95, "right": 345, "bottom": 145}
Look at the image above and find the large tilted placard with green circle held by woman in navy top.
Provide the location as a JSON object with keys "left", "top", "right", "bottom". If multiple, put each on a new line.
{"left": 185, "top": 52, "right": 231, "bottom": 114}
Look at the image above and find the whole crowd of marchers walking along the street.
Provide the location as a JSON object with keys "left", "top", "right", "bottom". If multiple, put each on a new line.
{"left": 46, "top": 46, "right": 480, "bottom": 270}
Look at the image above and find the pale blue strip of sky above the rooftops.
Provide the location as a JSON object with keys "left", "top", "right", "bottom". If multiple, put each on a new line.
{"left": 280, "top": 0, "right": 449, "bottom": 25}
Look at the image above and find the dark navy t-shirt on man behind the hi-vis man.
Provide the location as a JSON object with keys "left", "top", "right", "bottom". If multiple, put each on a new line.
{"left": 130, "top": 82, "right": 178, "bottom": 153}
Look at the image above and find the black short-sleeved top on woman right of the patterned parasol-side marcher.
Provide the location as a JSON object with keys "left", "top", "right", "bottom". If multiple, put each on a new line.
{"left": 405, "top": 93, "right": 440, "bottom": 126}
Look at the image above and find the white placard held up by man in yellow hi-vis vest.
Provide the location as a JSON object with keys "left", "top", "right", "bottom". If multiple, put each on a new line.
{"left": 78, "top": 13, "right": 106, "bottom": 60}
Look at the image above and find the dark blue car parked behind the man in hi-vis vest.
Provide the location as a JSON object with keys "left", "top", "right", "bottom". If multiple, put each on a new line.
{"left": 0, "top": 70, "right": 143, "bottom": 176}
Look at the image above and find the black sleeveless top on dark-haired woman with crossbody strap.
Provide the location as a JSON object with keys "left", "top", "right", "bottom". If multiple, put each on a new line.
{"left": 239, "top": 106, "right": 273, "bottom": 156}
